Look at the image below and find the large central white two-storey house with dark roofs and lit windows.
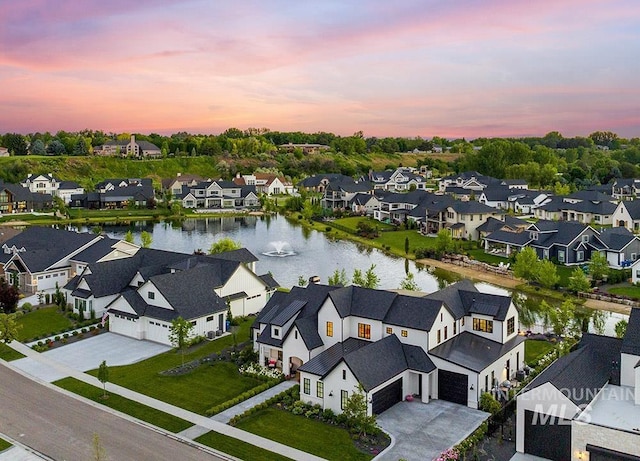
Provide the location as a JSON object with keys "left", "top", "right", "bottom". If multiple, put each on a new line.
{"left": 253, "top": 280, "right": 524, "bottom": 413}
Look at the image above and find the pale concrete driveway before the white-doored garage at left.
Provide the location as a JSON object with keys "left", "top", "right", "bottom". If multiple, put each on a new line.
{"left": 13, "top": 333, "right": 171, "bottom": 382}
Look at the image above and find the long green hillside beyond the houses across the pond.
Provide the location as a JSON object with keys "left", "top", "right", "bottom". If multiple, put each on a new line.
{"left": 0, "top": 153, "right": 456, "bottom": 189}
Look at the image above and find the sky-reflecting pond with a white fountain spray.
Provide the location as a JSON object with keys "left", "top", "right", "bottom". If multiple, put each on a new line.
{"left": 81, "top": 215, "right": 628, "bottom": 335}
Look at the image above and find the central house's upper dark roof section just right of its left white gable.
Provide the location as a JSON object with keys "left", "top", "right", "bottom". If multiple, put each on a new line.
{"left": 329, "top": 286, "right": 397, "bottom": 320}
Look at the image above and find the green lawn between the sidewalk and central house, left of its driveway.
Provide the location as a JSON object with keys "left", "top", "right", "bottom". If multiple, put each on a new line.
{"left": 236, "top": 408, "right": 373, "bottom": 461}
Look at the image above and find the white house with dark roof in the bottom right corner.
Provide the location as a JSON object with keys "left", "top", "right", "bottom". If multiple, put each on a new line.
{"left": 516, "top": 308, "right": 640, "bottom": 461}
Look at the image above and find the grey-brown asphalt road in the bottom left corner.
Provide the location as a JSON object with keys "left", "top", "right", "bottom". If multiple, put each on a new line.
{"left": 0, "top": 364, "right": 224, "bottom": 461}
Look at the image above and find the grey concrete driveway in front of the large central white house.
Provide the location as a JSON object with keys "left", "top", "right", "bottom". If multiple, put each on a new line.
{"left": 375, "top": 400, "right": 489, "bottom": 461}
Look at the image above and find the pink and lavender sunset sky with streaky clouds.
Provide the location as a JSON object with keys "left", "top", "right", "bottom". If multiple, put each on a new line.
{"left": 0, "top": 0, "right": 640, "bottom": 138}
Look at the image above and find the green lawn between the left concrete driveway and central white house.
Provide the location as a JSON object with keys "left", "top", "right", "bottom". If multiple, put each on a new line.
{"left": 89, "top": 319, "right": 262, "bottom": 414}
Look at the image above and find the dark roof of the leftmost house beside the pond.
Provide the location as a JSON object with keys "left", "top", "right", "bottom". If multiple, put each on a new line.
{"left": 0, "top": 226, "right": 98, "bottom": 273}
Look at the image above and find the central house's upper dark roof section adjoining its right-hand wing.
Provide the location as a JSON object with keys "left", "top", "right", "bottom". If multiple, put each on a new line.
{"left": 384, "top": 295, "right": 442, "bottom": 331}
